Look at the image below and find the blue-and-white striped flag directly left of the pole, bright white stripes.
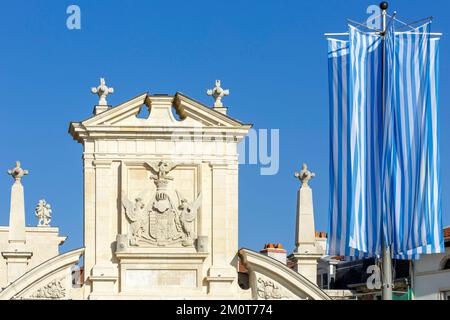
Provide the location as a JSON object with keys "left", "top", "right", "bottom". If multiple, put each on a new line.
{"left": 349, "top": 26, "right": 383, "bottom": 255}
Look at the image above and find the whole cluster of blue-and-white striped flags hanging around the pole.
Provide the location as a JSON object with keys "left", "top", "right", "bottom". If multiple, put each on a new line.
{"left": 328, "top": 24, "right": 443, "bottom": 258}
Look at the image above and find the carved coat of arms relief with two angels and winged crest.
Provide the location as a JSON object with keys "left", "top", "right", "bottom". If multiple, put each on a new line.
{"left": 122, "top": 161, "right": 202, "bottom": 247}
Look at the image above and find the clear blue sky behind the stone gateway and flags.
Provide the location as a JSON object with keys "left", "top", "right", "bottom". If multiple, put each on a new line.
{"left": 0, "top": 0, "right": 450, "bottom": 251}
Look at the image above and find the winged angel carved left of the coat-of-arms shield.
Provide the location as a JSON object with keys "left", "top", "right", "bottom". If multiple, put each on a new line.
{"left": 122, "top": 193, "right": 150, "bottom": 246}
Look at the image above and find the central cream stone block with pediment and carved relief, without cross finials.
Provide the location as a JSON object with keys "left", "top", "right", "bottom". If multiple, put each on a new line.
{"left": 70, "top": 89, "right": 251, "bottom": 298}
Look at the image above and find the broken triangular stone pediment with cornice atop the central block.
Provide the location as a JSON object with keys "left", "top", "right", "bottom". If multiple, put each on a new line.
{"left": 69, "top": 93, "right": 251, "bottom": 142}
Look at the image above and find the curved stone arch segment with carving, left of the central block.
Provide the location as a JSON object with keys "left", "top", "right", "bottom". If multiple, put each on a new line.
{"left": 0, "top": 248, "right": 84, "bottom": 300}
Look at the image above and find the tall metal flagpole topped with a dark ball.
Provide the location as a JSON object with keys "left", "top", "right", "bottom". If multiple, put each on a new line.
{"left": 380, "top": 2, "right": 392, "bottom": 300}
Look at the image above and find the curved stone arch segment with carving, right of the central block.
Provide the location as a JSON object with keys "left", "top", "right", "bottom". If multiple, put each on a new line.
{"left": 239, "top": 249, "right": 331, "bottom": 300}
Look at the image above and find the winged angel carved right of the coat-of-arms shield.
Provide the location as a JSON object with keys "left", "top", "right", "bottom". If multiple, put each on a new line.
{"left": 177, "top": 191, "right": 202, "bottom": 247}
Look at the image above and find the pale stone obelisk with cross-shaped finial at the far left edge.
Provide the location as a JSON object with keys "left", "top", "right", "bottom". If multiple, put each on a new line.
{"left": 2, "top": 161, "right": 32, "bottom": 283}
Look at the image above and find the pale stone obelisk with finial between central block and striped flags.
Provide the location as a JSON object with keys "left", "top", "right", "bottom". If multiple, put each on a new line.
{"left": 290, "top": 164, "right": 322, "bottom": 283}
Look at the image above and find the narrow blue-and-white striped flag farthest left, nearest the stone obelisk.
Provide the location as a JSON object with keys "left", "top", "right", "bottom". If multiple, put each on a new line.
{"left": 328, "top": 39, "right": 354, "bottom": 256}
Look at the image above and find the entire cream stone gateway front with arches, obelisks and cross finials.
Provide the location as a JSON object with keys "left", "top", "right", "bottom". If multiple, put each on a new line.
{"left": 0, "top": 79, "right": 328, "bottom": 300}
